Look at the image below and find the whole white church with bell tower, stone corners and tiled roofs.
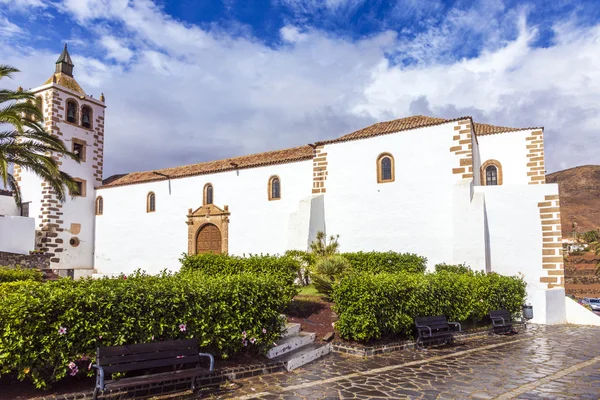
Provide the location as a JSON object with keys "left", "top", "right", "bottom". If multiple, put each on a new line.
{"left": 0, "top": 47, "right": 566, "bottom": 323}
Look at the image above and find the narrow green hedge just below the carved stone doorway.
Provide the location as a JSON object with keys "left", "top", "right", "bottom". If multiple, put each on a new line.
{"left": 179, "top": 253, "right": 300, "bottom": 283}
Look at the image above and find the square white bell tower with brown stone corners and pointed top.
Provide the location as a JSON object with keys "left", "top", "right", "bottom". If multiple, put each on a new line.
{"left": 15, "top": 44, "right": 106, "bottom": 278}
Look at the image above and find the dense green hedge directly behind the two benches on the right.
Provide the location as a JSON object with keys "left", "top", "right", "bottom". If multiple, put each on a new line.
{"left": 333, "top": 271, "right": 525, "bottom": 342}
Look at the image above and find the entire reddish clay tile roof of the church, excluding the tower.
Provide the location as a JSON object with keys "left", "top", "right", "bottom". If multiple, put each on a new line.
{"left": 100, "top": 115, "right": 543, "bottom": 188}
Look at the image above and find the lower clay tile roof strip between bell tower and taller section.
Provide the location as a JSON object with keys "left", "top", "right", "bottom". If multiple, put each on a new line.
{"left": 100, "top": 146, "right": 313, "bottom": 188}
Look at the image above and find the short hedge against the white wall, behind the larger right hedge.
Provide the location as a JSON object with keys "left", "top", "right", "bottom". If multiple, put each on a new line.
{"left": 342, "top": 251, "right": 427, "bottom": 274}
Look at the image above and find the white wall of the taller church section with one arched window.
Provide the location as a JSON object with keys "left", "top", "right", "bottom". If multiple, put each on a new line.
{"left": 325, "top": 123, "right": 460, "bottom": 268}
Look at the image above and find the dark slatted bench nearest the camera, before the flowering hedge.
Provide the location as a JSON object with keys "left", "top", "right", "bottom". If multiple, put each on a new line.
{"left": 92, "top": 339, "right": 215, "bottom": 400}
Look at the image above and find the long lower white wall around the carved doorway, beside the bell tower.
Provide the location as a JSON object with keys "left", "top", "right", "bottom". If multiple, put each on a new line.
{"left": 95, "top": 160, "right": 312, "bottom": 274}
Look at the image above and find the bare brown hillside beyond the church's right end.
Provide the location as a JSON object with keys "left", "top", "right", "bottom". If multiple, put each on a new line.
{"left": 546, "top": 165, "right": 600, "bottom": 237}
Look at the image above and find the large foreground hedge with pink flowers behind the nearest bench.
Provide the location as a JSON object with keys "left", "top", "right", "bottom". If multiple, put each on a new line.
{"left": 0, "top": 273, "right": 296, "bottom": 388}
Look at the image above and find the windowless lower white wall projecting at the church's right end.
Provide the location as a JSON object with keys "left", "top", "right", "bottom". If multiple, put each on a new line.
{"left": 475, "top": 184, "right": 566, "bottom": 324}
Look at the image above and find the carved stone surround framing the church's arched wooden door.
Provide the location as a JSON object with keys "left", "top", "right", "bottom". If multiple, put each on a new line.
{"left": 186, "top": 204, "right": 230, "bottom": 254}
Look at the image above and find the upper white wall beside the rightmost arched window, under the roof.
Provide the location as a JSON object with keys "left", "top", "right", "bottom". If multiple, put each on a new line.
{"left": 476, "top": 129, "right": 539, "bottom": 185}
